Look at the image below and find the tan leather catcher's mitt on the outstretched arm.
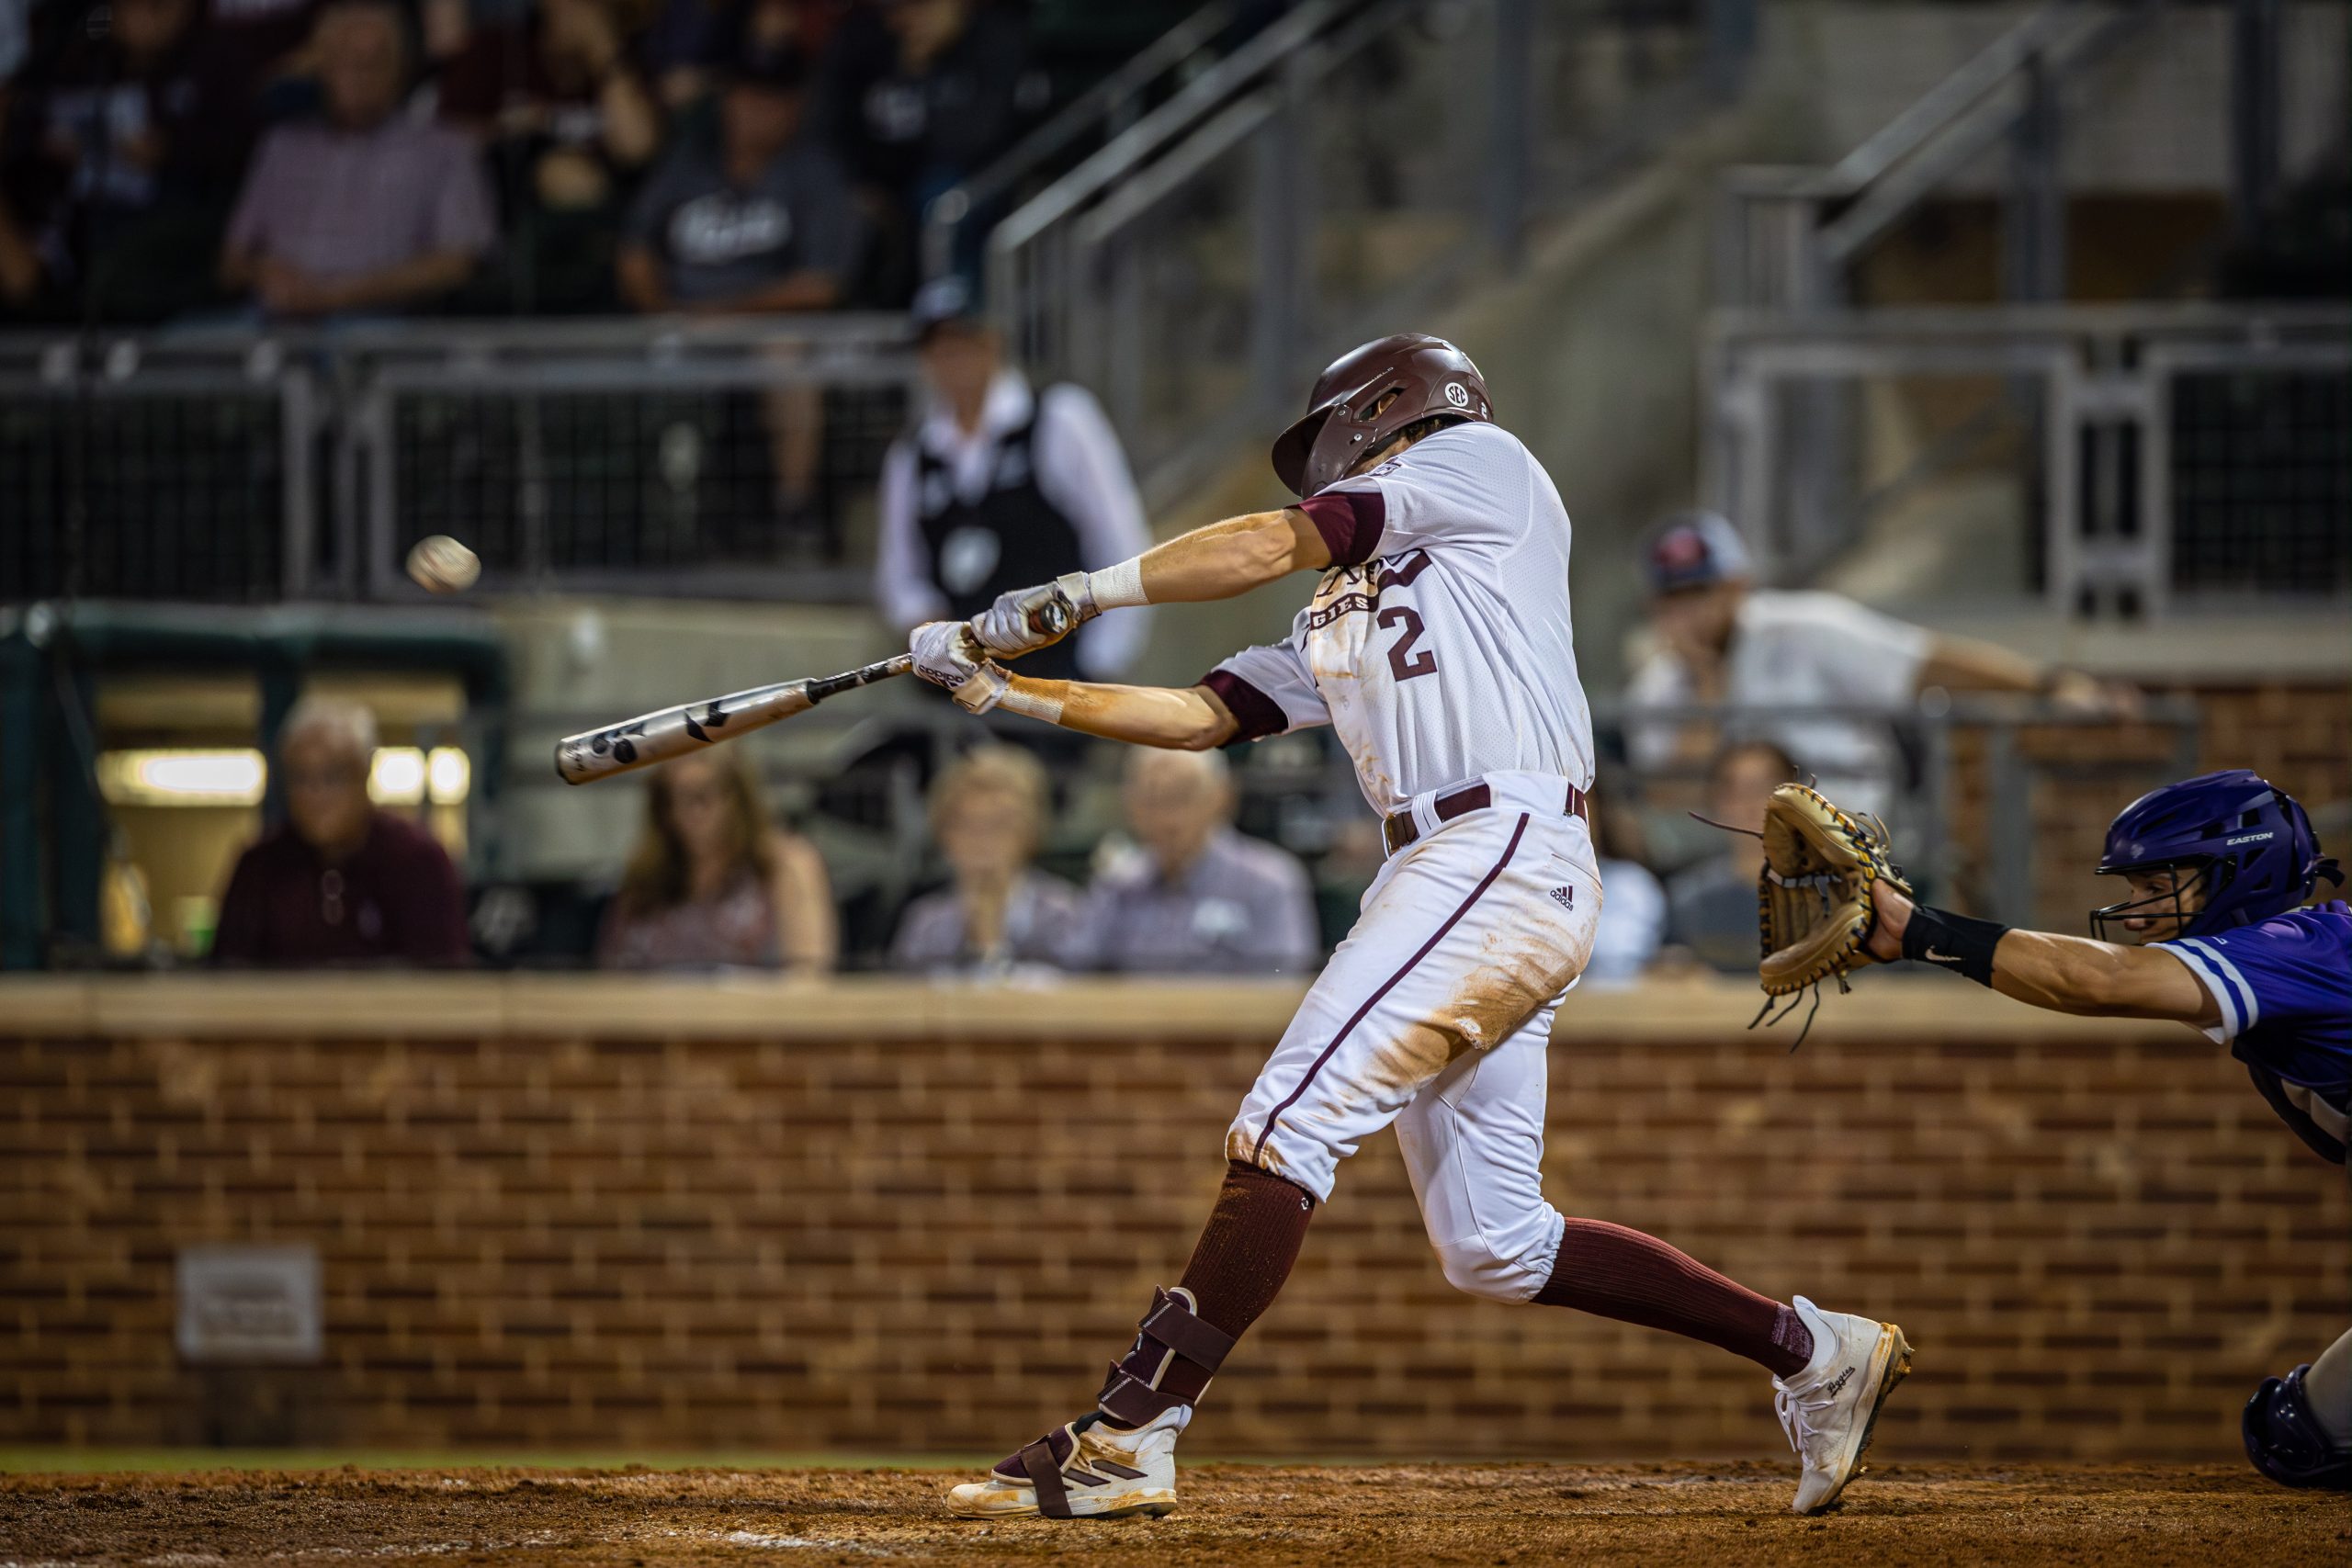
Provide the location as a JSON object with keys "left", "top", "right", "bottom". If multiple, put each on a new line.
{"left": 1757, "top": 783, "right": 1912, "bottom": 1006}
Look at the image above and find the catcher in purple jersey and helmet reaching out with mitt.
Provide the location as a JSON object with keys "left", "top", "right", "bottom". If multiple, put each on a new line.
{"left": 1759, "top": 769, "right": 2352, "bottom": 1491}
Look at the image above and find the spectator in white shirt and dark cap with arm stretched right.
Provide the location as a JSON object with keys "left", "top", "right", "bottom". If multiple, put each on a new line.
{"left": 1625, "top": 513, "right": 2135, "bottom": 813}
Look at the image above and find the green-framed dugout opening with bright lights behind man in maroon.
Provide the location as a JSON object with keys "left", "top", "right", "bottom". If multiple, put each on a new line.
{"left": 0, "top": 600, "right": 511, "bottom": 968}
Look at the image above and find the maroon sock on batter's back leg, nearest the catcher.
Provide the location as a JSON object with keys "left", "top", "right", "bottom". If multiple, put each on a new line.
{"left": 1536, "top": 1220, "right": 1814, "bottom": 1378}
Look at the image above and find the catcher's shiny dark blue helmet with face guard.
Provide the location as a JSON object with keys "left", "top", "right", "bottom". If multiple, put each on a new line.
{"left": 2091, "top": 769, "right": 2343, "bottom": 941}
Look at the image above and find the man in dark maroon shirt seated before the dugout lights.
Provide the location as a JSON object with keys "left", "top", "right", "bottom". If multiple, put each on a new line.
{"left": 211, "top": 698, "right": 468, "bottom": 968}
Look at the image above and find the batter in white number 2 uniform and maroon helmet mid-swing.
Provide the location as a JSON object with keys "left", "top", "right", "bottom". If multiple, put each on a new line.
{"left": 910, "top": 333, "right": 1910, "bottom": 1518}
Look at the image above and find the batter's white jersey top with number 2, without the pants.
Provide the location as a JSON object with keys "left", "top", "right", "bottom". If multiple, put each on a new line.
{"left": 1202, "top": 423, "right": 1592, "bottom": 816}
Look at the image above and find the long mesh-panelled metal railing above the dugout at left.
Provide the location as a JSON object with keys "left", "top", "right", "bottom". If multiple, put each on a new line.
{"left": 0, "top": 315, "right": 917, "bottom": 602}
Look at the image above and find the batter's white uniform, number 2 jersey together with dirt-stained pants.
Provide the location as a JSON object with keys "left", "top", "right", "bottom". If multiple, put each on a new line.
{"left": 1204, "top": 423, "right": 1601, "bottom": 1300}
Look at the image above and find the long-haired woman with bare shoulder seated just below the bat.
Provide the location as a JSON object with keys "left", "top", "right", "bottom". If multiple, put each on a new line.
{"left": 597, "top": 750, "right": 840, "bottom": 974}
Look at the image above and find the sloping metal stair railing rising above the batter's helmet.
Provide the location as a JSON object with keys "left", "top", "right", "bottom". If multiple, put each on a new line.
{"left": 988, "top": 0, "right": 1750, "bottom": 503}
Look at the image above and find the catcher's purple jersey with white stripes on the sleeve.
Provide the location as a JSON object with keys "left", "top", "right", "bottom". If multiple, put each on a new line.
{"left": 2157, "top": 898, "right": 2352, "bottom": 1161}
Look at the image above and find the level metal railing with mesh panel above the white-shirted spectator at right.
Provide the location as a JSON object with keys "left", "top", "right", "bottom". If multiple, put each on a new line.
{"left": 1702, "top": 306, "right": 2352, "bottom": 616}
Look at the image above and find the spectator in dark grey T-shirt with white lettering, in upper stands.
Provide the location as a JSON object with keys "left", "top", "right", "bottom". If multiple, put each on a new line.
{"left": 621, "top": 47, "right": 861, "bottom": 525}
